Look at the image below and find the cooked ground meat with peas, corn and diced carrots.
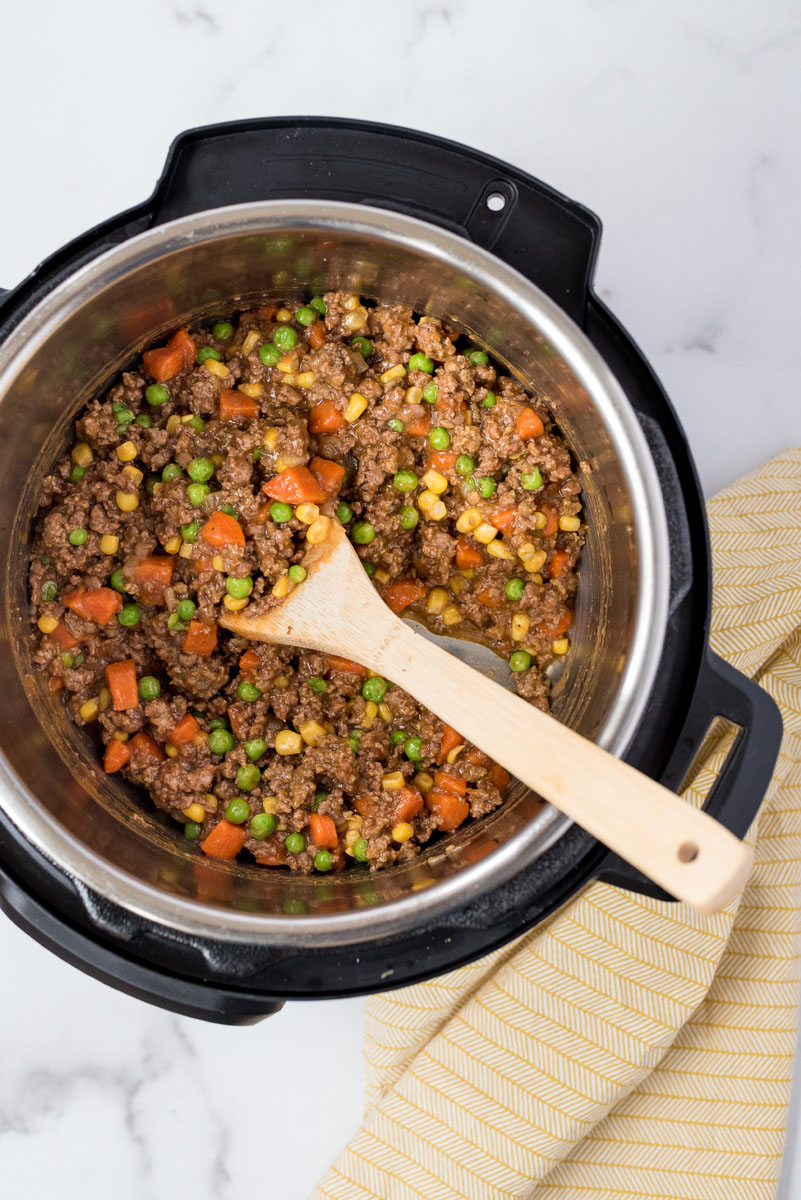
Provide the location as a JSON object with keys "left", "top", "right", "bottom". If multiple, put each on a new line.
{"left": 30, "top": 293, "right": 584, "bottom": 872}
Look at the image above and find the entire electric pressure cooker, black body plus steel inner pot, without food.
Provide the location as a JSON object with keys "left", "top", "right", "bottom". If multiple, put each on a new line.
{"left": 0, "top": 118, "right": 781, "bottom": 1022}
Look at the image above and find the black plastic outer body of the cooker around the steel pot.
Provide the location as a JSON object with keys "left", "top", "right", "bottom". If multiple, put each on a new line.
{"left": 0, "top": 118, "right": 781, "bottom": 1024}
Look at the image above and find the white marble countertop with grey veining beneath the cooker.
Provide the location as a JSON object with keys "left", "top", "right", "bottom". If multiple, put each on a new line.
{"left": 0, "top": 0, "right": 801, "bottom": 1200}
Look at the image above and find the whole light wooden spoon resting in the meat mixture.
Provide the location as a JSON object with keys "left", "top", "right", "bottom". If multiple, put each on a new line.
{"left": 221, "top": 518, "right": 752, "bottom": 912}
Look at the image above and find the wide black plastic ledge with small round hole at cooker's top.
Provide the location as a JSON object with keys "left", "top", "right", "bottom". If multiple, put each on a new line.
{"left": 147, "top": 116, "right": 601, "bottom": 326}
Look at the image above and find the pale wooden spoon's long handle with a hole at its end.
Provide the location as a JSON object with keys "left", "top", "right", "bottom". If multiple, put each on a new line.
{"left": 366, "top": 610, "right": 752, "bottom": 912}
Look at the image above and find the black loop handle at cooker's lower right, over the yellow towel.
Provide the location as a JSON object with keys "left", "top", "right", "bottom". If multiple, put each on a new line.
{"left": 597, "top": 649, "right": 782, "bottom": 900}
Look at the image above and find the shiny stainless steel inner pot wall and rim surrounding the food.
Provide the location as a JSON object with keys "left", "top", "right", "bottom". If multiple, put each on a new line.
{"left": 0, "top": 200, "right": 670, "bottom": 946}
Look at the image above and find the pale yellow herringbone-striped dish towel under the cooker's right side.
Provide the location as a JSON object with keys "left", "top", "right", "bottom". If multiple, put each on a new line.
{"left": 313, "top": 450, "right": 801, "bottom": 1200}
